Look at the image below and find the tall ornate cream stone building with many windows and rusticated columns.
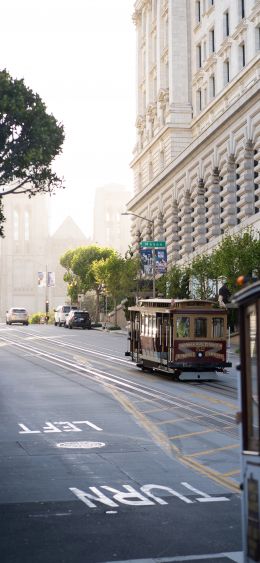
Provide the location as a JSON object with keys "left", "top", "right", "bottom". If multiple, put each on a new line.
{"left": 127, "top": 0, "right": 260, "bottom": 264}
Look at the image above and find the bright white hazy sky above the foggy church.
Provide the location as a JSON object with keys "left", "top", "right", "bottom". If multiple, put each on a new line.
{"left": 0, "top": 0, "right": 135, "bottom": 236}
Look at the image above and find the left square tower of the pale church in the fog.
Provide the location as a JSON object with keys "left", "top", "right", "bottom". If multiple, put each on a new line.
{"left": 0, "top": 194, "right": 49, "bottom": 318}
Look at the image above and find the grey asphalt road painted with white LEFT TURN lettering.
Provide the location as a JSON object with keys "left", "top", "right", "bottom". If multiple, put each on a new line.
{"left": 0, "top": 324, "right": 242, "bottom": 563}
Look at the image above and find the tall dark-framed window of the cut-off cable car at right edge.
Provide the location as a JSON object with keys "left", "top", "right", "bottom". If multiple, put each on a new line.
{"left": 245, "top": 305, "right": 260, "bottom": 451}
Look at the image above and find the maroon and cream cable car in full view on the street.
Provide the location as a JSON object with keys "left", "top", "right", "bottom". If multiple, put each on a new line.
{"left": 126, "top": 298, "right": 231, "bottom": 380}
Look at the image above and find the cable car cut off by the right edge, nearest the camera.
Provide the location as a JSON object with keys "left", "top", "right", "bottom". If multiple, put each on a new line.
{"left": 233, "top": 281, "right": 260, "bottom": 563}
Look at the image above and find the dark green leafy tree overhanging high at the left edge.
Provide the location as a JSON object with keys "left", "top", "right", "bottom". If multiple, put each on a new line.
{"left": 0, "top": 70, "right": 64, "bottom": 236}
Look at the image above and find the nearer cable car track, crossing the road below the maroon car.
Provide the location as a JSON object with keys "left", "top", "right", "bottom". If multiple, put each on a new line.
{"left": 0, "top": 336, "right": 237, "bottom": 438}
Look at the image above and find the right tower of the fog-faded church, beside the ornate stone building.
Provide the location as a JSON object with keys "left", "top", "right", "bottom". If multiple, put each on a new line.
{"left": 93, "top": 184, "right": 131, "bottom": 255}
